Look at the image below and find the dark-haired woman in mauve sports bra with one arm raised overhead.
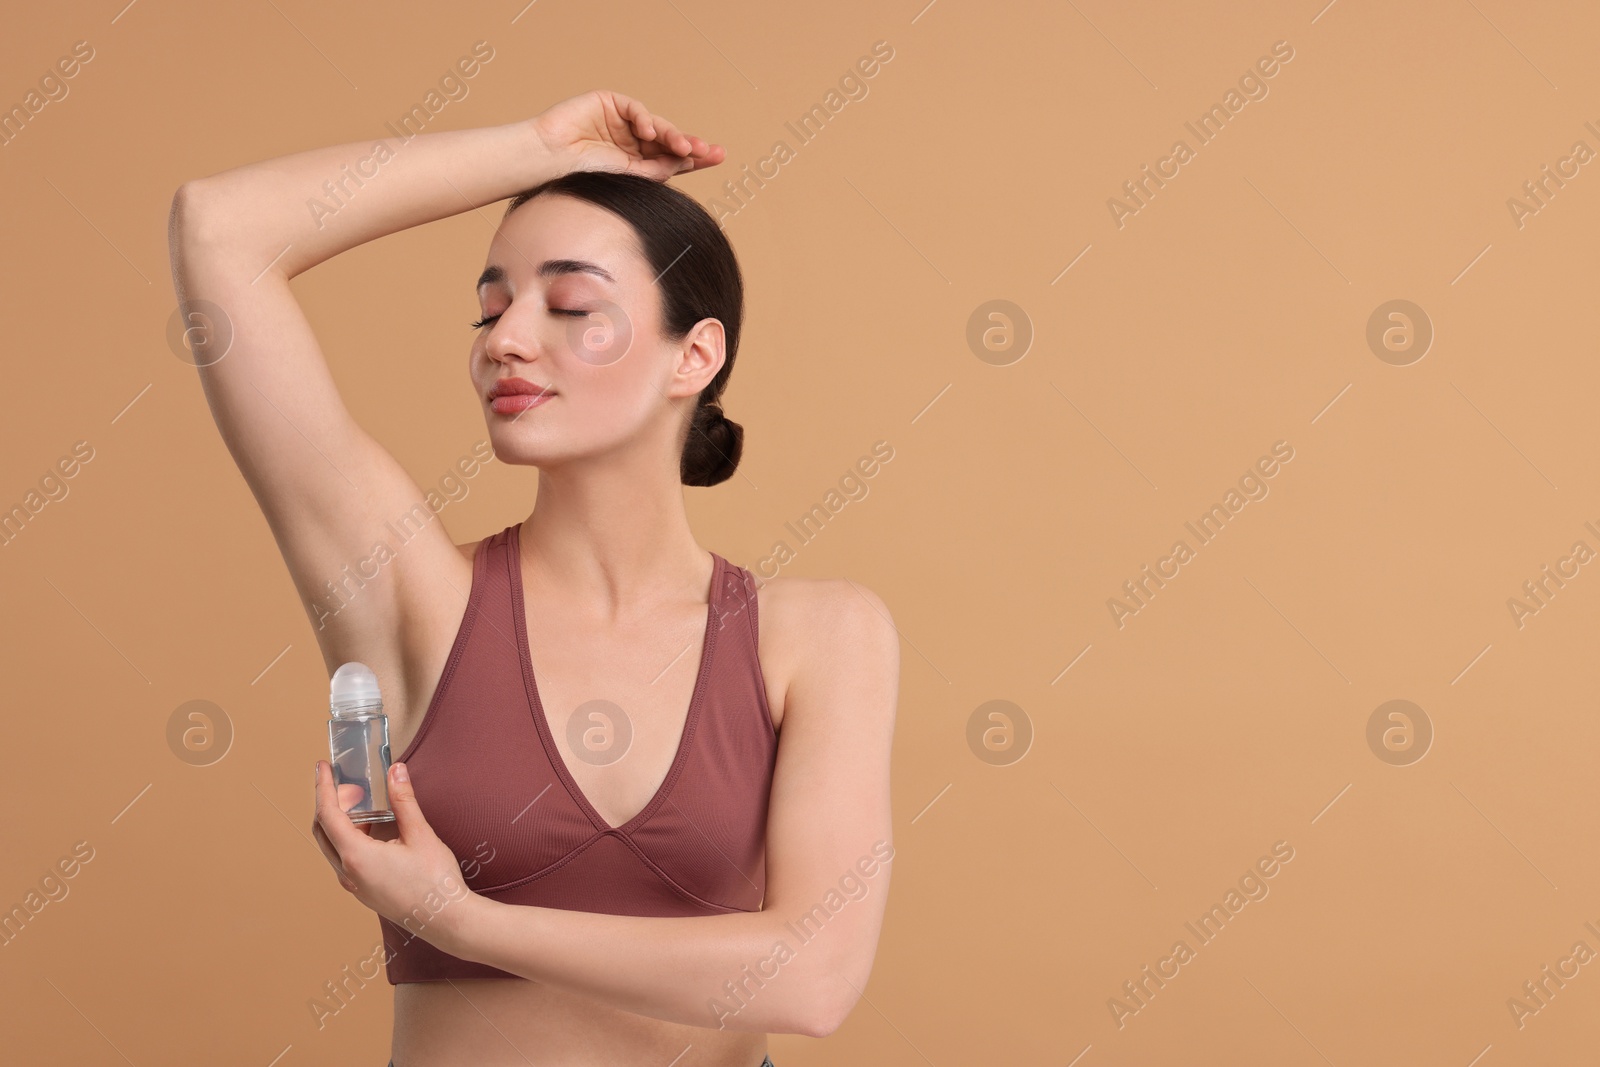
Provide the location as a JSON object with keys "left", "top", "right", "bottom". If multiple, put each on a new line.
{"left": 171, "top": 91, "right": 899, "bottom": 1067}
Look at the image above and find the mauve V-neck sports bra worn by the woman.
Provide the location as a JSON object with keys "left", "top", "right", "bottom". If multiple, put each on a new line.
{"left": 379, "top": 523, "right": 778, "bottom": 985}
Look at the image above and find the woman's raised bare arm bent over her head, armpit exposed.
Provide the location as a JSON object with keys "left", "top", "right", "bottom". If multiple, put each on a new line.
{"left": 170, "top": 91, "right": 720, "bottom": 707}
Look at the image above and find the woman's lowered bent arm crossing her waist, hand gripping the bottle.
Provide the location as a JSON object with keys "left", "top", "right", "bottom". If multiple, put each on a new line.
{"left": 305, "top": 579, "right": 899, "bottom": 1037}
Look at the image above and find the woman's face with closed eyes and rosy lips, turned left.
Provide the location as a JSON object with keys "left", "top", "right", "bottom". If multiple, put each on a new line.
{"left": 470, "top": 194, "right": 720, "bottom": 470}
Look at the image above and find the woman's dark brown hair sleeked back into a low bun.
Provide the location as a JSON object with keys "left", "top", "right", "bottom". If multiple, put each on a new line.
{"left": 506, "top": 171, "right": 744, "bottom": 485}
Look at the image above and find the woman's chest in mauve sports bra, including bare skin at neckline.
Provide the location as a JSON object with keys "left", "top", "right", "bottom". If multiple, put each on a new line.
{"left": 392, "top": 531, "right": 778, "bottom": 915}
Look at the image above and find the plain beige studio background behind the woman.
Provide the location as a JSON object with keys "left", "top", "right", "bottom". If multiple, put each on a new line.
{"left": 0, "top": 0, "right": 1600, "bottom": 1067}
